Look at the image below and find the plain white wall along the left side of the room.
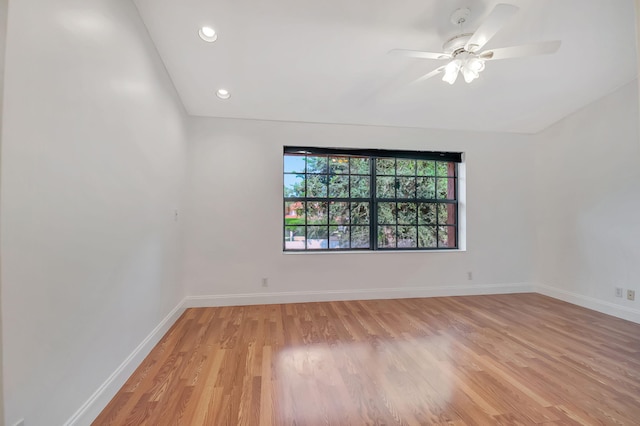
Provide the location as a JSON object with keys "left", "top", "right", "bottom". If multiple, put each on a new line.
{"left": 1, "top": 0, "right": 186, "bottom": 426}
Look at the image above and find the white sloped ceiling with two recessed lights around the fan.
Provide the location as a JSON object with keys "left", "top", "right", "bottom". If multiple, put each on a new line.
{"left": 134, "top": 0, "right": 637, "bottom": 133}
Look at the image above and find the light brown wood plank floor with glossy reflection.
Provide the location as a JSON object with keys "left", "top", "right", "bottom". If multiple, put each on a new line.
{"left": 94, "top": 294, "right": 640, "bottom": 426}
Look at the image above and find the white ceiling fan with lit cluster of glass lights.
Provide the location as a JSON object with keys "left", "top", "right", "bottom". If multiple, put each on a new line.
{"left": 389, "top": 3, "right": 561, "bottom": 84}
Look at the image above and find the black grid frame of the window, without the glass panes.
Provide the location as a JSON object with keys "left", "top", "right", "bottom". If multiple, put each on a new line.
{"left": 281, "top": 146, "right": 463, "bottom": 253}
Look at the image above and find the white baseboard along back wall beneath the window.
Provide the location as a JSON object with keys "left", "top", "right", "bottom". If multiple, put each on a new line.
{"left": 184, "top": 283, "right": 533, "bottom": 308}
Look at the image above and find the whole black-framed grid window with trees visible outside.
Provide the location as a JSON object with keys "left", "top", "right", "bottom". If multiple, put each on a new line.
{"left": 283, "top": 147, "right": 462, "bottom": 251}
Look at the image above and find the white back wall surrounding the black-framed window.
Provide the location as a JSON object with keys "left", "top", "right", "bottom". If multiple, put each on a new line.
{"left": 183, "top": 118, "right": 533, "bottom": 305}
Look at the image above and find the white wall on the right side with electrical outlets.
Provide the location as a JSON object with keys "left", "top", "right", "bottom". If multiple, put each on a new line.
{"left": 535, "top": 81, "right": 640, "bottom": 322}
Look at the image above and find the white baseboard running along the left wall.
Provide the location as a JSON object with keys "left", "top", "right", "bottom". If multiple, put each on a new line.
{"left": 64, "top": 301, "right": 184, "bottom": 426}
